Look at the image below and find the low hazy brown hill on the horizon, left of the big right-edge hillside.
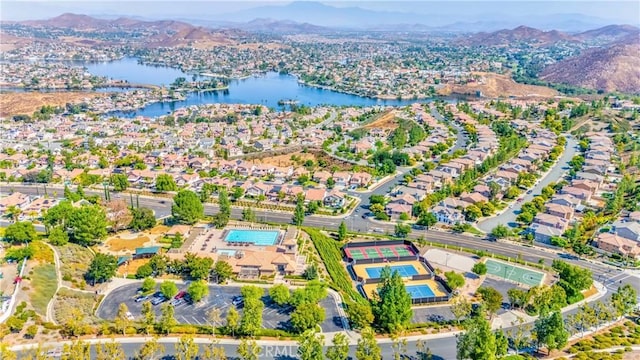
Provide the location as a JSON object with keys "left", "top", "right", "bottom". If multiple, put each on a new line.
{"left": 459, "top": 26, "right": 576, "bottom": 46}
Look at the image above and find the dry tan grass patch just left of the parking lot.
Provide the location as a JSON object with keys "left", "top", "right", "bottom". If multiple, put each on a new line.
{"left": 53, "top": 288, "right": 102, "bottom": 324}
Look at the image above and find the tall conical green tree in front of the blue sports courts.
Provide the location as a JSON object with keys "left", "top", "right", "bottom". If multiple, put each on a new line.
{"left": 373, "top": 266, "right": 413, "bottom": 333}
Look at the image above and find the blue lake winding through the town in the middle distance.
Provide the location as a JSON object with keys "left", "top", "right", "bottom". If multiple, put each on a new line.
{"left": 80, "top": 58, "right": 455, "bottom": 117}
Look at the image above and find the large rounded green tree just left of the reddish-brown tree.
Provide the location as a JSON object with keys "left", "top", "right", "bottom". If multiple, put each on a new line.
{"left": 69, "top": 205, "right": 108, "bottom": 246}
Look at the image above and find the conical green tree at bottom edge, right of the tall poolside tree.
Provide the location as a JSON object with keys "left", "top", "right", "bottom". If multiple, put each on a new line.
{"left": 456, "top": 312, "right": 497, "bottom": 360}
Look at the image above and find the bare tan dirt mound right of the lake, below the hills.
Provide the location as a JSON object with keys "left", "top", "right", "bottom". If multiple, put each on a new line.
{"left": 441, "top": 73, "right": 558, "bottom": 98}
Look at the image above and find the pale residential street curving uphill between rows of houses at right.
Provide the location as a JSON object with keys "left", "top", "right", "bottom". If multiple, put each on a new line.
{"left": 477, "top": 137, "right": 578, "bottom": 233}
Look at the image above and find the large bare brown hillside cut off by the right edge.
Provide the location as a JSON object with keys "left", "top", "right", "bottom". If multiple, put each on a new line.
{"left": 540, "top": 42, "right": 640, "bottom": 93}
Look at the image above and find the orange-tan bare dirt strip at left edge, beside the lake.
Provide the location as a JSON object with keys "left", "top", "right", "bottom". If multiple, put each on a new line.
{"left": 0, "top": 92, "right": 105, "bottom": 116}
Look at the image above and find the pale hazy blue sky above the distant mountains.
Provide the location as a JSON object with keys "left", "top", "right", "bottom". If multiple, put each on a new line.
{"left": 0, "top": 0, "right": 640, "bottom": 24}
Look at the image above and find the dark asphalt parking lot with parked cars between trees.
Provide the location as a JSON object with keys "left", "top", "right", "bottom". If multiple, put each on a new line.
{"left": 97, "top": 284, "right": 342, "bottom": 332}
